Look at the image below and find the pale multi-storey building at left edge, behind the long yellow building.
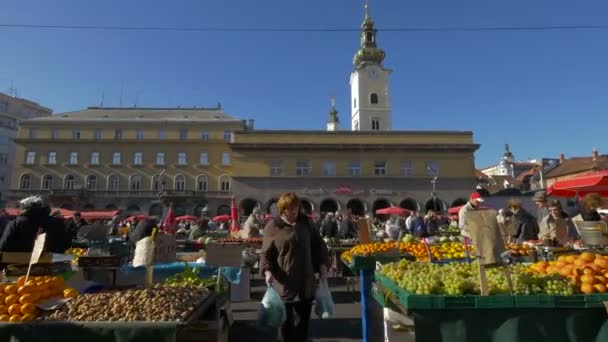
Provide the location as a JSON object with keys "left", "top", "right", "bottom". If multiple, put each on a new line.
{"left": 0, "top": 93, "right": 53, "bottom": 207}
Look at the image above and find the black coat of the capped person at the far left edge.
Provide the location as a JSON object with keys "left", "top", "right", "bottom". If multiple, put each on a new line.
{"left": 0, "top": 215, "right": 44, "bottom": 252}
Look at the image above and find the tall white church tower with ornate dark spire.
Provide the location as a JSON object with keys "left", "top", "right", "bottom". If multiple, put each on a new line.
{"left": 350, "top": 4, "right": 392, "bottom": 131}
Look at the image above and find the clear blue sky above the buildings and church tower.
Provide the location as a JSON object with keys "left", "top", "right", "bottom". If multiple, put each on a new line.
{"left": 0, "top": 0, "right": 608, "bottom": 166}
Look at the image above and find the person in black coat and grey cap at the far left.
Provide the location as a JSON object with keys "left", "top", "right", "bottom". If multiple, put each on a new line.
{"left": 0, "top": 196, "right": 51, "bottom": 252}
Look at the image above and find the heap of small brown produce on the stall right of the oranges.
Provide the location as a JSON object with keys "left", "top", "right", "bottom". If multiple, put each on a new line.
{"left": 48, "top": 284, "right": 209, "bottom": 322}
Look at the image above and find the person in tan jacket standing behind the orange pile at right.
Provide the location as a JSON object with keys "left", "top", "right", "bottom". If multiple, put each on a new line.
{"left": 539, "top": 201, "right": 578, "bottom": 246}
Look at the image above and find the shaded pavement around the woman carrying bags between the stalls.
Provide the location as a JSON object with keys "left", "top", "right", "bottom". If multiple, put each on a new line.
{"left": 230, "top": 278, "right": 404, "bottom": 342}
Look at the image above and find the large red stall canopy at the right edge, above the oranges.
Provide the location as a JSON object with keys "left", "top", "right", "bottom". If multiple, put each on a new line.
{"left": 547, "top": 170, "right": 608, "bottom": 197}
